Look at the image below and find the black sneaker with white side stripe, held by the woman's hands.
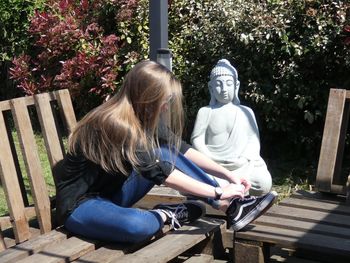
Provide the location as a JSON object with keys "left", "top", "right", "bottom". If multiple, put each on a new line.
{"left": 226, "top": 191, "right": 278, "bottom": 231}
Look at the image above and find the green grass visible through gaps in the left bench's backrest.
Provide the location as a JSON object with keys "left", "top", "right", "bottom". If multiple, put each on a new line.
{"left": 0, "top": 132, "right": 62, "bottom": 216}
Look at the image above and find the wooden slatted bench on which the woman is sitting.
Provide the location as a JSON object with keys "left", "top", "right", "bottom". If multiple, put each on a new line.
{"left": 0, "top": 90, "right": 226, "bottom": 263}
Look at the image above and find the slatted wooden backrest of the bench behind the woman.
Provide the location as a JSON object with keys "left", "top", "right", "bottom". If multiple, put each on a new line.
{"left": 0, "top": 90, "right": 76, "bottom": 250}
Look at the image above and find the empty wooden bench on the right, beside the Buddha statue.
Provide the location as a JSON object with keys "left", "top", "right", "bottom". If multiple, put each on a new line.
{"left": 231, "top": 89, "right": 350, "bottom": 263}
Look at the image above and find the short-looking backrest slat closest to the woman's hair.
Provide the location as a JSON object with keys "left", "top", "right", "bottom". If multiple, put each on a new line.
{"left": 54, "top": 90, "right": 77, "bottom": 133}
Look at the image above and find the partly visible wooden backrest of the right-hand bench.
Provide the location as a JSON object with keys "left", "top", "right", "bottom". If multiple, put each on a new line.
{"left": 316, "top": 89, "right": 350, "bottom": 194}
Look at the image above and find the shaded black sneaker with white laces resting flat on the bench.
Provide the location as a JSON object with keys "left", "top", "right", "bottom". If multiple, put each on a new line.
{"left": 153, "top": 201, "right": 205, "bottom": 230}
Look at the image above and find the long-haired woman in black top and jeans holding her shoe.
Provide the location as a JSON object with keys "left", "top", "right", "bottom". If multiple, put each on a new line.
{"left": 55, "top": 61, "right": 276, "bottom": 243}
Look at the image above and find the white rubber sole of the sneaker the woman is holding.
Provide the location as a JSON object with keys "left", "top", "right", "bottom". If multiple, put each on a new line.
{"left": 231, "top": 191, "right": 278, "bottom": 231}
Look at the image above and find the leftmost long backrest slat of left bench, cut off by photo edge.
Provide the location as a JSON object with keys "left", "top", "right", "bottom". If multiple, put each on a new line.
{"left": 0, "top": 112, "right": 30, "bottom": 243}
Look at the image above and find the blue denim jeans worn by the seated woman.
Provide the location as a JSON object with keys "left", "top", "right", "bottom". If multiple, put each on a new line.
{"left": 65, "top": 147, "right": 218, "bottom": 243}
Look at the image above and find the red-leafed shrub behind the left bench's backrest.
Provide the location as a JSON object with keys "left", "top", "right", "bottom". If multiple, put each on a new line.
{"left": 10, "top": 0, "right": 137, "bottom": 113}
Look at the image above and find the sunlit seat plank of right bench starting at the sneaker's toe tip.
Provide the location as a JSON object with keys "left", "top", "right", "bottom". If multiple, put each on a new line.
{"left": 279, "top": 198, "right": 350, "bottom": 216}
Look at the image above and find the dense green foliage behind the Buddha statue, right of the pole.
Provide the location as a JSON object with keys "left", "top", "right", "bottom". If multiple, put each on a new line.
{"left": 165, "top": 0, "right": 350, "bottom": 167}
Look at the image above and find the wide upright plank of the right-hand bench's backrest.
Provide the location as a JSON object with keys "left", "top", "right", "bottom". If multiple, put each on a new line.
{"left": 316, "top": 89, "right": 347, "bottom": 192}
